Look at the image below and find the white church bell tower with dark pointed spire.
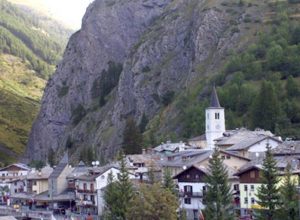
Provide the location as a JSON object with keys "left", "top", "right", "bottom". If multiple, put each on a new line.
{"left": 205, "top": 87, "right": 225, "bottom": 149}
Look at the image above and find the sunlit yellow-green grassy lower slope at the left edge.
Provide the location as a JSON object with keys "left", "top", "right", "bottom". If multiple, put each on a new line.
{"left": 0, "top": 54, "right": 46, "bottom": 162}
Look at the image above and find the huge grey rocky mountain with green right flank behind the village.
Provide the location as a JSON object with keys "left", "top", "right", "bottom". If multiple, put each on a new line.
{"left": 25, "top": 0, "right": 299, "bottom": 162}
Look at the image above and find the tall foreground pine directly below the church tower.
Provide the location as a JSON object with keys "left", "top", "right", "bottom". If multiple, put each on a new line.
{"left": 204, "top": 149, "right": 234, "bottom": 220}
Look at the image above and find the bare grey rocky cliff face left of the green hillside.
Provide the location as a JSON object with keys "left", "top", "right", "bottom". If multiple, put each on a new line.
{"left": 26, "top": 0, "right": 246, "bottom": 160}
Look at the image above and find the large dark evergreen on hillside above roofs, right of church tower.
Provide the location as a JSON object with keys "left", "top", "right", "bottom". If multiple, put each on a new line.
{"left": 252, "top": 81, "right": 280, "bottom": 132}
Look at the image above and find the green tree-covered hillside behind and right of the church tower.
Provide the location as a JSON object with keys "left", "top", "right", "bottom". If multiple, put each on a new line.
{"left": 144, "top": 1, "right": 300, "bottom": 145}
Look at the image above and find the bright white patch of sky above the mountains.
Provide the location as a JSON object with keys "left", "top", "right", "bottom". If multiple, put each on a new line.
{"left": 9, "top": 0, "right": 94, "bottom": 30}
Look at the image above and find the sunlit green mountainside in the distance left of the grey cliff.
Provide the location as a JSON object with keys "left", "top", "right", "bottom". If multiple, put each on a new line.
{"left": 0, "top": 0, "right": 71, "bottom": 163}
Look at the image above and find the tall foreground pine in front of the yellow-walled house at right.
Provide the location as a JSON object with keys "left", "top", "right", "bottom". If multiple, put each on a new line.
{"left": 256, "top": 145, "right": 280, "bottom": 220}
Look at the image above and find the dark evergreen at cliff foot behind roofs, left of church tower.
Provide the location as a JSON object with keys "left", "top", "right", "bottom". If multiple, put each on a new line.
{"left": 123, "top": 117, "right": 143, "bottom": 154}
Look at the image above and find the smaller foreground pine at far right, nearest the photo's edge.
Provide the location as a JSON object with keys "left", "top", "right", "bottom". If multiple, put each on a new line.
{"left": 280, "top": 164, "right": 299, "bottom": 220}
